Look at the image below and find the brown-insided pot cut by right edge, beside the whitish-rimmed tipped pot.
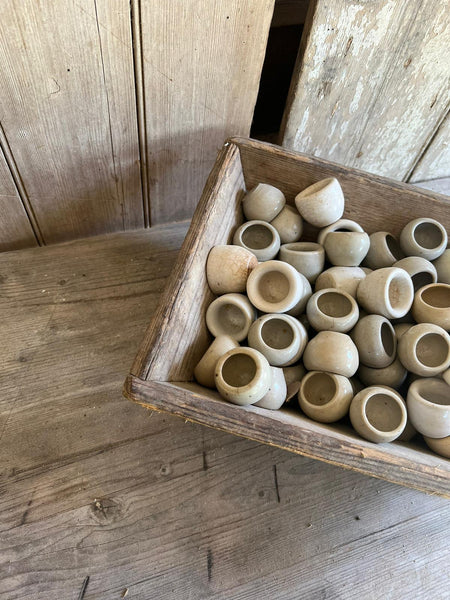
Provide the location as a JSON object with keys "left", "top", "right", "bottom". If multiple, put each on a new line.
{"left": 411, "top": 283, "right": 450, "bottom": 331}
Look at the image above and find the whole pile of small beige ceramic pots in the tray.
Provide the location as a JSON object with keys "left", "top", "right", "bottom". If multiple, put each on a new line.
{"left": 194, "top": 178, "right": 450, "bottom": 457}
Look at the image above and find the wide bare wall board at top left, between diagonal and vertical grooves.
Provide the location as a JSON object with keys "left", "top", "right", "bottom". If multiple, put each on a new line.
{"left": 0, "top": 0, "right": 144, "bottom": 243}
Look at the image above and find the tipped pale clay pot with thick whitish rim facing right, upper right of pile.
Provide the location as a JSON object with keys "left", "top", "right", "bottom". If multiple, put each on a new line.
{"left": 356, "top": 267, "right": 414, "bottom": 319}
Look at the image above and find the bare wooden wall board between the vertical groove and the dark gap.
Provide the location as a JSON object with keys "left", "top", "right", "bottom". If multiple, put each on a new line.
{"left": 141, "top": 0, "right": 274, "bottom": 224}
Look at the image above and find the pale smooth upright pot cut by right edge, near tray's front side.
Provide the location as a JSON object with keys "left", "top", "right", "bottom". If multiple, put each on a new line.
{"left": 406, "top": 378, "right": 450, "bottom": 438}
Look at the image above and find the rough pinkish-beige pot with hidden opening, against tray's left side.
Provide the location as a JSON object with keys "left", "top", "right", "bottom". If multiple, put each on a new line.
{"left": 206, "top": 241, "right": 258, "bottom": 296}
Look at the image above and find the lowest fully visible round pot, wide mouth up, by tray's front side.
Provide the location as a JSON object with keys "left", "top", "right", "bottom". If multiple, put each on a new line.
{"left": 350, "top": 386, "right": 407, "bottom": 444}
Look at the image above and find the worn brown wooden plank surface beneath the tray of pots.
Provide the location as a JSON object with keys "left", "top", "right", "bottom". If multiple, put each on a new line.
{"left": 0, "top": 217, "right": 450, "bottom": 600}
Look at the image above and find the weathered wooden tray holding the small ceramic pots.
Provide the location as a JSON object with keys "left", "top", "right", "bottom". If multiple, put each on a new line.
{"left": 124, "top": 138, "right": 450, "bottom": 497}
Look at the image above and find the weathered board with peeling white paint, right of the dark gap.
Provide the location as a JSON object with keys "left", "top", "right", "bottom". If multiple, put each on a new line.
{"left": 282, "top": 0, "right": 450, "bottom": 179}
